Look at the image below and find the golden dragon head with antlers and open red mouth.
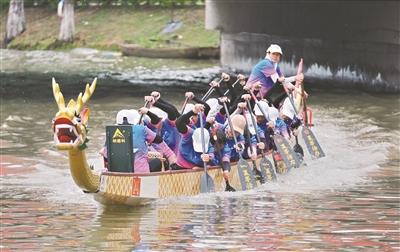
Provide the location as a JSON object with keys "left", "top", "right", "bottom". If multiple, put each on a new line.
{"left": 52, "top": 78, "right": 97, "bottom": 150}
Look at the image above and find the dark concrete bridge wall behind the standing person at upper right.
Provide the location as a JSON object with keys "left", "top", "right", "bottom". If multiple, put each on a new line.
{"left": 206, "top": 0, "right": 400, "bottom": 92}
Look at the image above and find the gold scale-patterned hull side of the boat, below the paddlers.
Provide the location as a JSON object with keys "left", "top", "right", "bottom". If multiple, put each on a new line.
{"left": 95, "top": 160, "right": 260, "bottom": 205}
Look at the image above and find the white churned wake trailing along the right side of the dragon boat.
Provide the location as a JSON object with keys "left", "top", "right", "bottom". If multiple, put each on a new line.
{"left": 155, "top": 105, "right": 396, "bottom": 205}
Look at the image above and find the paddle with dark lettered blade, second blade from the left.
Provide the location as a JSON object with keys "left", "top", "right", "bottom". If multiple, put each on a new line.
{"left": 223, "top": 99, "right": 257, "bottom": 190}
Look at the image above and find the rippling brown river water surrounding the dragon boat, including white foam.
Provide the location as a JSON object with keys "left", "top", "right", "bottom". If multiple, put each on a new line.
{"left": 0, "top": 49, "right": 400, "bottom": 251}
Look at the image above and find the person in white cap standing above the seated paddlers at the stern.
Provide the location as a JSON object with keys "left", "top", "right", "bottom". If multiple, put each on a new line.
{"left": 245, "top": 44, "right": 304, "bottom": 98}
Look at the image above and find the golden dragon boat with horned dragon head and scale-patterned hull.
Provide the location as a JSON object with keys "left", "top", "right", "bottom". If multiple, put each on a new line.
{"left": 52, "top": 78, "right": 280, "bottom": 205}
